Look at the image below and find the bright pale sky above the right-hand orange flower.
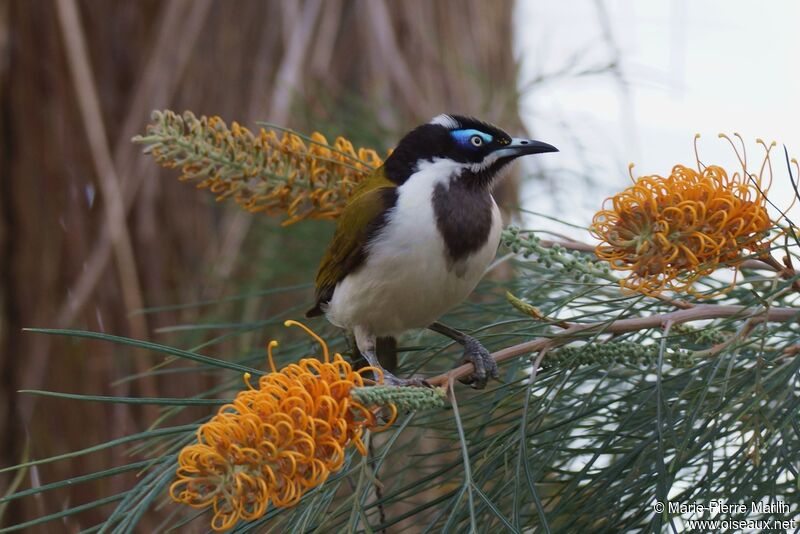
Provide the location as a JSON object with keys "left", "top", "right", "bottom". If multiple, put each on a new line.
{"left": 515, "top": 0, "right": 800, "bottom": 234}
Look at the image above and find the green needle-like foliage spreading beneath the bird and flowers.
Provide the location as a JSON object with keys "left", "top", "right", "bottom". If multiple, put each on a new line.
{"left": 0, "top": 216, "right": 800, "bottom": 532}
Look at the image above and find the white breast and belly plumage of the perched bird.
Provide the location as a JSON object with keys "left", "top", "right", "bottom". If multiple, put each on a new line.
{"left": 326, "top": 159, "right": 501, "bottom": 336}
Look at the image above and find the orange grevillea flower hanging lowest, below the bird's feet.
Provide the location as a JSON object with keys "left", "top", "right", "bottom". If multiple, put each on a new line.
{"left": 170, "top": 321, "right": 397, "bottom": 530}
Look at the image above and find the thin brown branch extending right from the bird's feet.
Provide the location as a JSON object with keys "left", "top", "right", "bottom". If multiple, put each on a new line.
{"left": 427, "top": 304, "right": 800, "bottom": 387}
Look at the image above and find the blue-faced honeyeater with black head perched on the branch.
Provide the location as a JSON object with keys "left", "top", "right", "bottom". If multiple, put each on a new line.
{"left": 306, "top": 114, "right": 558, "bottom": 389}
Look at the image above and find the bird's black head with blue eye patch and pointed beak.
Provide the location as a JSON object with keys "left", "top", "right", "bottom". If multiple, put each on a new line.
{"left": 385, "top": 114, "right": 558, "bottom": 187}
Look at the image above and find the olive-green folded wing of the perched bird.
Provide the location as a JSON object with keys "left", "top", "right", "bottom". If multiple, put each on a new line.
{"left": 306, "top": 167, "right": 397, "bottom": 317}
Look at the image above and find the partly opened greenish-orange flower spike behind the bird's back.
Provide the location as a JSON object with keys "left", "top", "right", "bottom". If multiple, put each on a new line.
{"left": 134, "top": 111, "right": 383, "bottom": 225}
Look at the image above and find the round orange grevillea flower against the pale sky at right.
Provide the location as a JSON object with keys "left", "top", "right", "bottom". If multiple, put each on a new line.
{"left": 592, "top": 137, "right": 774, "bottom": 294}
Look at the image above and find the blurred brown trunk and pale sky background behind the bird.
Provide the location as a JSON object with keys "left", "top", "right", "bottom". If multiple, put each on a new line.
{"left": 0, "top": 0, "right": 800, "bottom": 529}
